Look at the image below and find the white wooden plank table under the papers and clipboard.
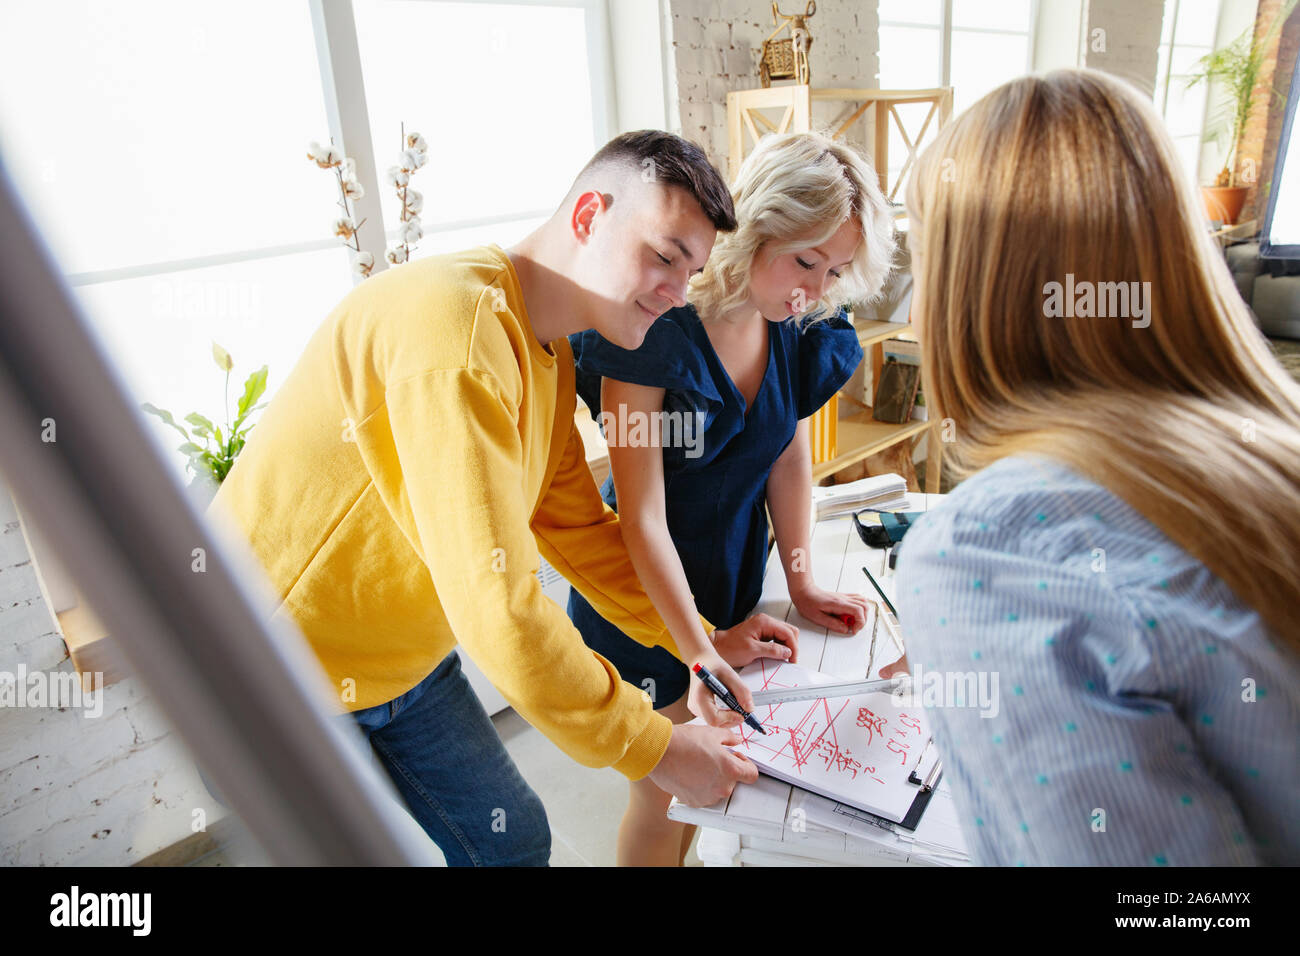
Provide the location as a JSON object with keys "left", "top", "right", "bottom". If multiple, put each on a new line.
{"left": 668, "top": 493, "right": 969, "bottom": 866}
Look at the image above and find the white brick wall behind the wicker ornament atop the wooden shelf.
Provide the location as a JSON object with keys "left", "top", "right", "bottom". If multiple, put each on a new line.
{"left": 668, "top": 0, "right": 879, "bottom": 173}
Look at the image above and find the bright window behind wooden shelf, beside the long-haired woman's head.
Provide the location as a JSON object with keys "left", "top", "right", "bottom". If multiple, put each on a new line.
{"left": 879, "top": 0, "right": 1035, "bottom": 193}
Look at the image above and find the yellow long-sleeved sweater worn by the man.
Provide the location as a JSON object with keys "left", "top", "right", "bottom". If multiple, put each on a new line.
{"left": 213, "top": 246, "right": 712, "bottom": 779}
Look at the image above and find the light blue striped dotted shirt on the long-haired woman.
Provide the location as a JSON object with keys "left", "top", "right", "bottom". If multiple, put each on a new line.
{"left": 896, "top": 455, "right": 1300, "bottom": 866}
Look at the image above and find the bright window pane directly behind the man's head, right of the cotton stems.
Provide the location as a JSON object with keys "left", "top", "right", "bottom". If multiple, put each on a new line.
{"left": 354, "top": 0, "right": 610, "bottom": 258}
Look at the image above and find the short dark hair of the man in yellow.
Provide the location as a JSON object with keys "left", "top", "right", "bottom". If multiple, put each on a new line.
{"left": 575, "top": 130, "right": 736, "bottom": 233}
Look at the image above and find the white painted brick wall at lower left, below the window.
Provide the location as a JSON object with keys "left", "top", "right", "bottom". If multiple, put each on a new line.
{"left": 0, "top": 485, "right": 228, "bottom": 866}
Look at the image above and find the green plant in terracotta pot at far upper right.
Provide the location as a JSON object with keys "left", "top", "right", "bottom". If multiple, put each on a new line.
{"left": 1187, "top": 0, "right": 1297, "bottom": 224}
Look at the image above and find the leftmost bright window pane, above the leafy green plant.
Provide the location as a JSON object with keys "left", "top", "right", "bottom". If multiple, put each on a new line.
{"left": 0, "top": 0, "right": 350, "bottom": 447}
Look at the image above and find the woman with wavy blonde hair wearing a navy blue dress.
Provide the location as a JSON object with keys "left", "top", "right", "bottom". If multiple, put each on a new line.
{"left": 569, "top": 134, "right": 894, "bottom": 865}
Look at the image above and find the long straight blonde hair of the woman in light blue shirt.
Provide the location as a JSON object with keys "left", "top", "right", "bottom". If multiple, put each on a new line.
{"left": 907, "top": 70, "right": 1300, "bottom": 653}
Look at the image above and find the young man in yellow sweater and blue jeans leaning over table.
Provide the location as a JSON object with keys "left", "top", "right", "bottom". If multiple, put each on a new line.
{"left": 213, "top": 131, "right": 797, "bottom": 865}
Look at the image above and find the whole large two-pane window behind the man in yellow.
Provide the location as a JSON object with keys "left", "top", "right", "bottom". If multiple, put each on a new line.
{"left": 0, "top": 0, "right": 610, "bottom": 471}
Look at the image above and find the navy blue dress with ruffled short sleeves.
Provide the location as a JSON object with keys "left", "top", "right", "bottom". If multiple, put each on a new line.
{"left": 568, "top": 304, "right": 862, "bottom": 708}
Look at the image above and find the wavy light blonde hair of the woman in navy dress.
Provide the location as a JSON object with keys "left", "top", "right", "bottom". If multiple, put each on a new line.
{"left": 689, "top": 133, "right": 894, "bottom": 319}
